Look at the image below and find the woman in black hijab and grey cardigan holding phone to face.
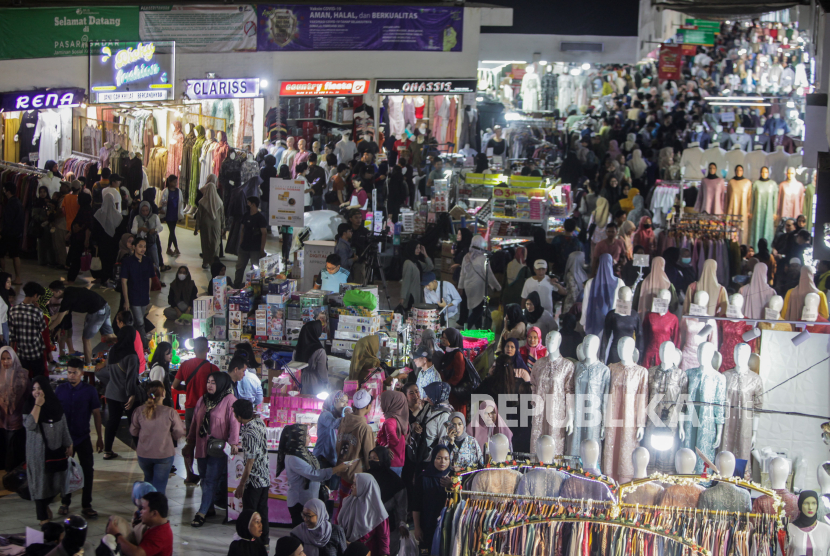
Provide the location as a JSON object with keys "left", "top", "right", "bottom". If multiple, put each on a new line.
{"left": 23, "top": 375, "right": 72, "bottom": 525}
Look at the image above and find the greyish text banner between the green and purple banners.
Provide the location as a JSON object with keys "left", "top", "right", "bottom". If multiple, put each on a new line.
{"left": 139, "top": 5, "right": 257, "bottom": 53}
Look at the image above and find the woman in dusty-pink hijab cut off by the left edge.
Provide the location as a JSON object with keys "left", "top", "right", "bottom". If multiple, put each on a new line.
{"left": 0, "top": 346, "right": 29, "bottom": 473}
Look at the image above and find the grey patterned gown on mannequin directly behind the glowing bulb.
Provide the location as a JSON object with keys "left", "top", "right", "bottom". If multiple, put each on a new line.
{"left": 640, "top": 365, "right": 689, "bottom": 475}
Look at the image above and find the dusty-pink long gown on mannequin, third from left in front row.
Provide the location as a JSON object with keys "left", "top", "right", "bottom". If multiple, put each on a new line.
{"left": 602, "top": 362, "right": 648, "bottom": 483}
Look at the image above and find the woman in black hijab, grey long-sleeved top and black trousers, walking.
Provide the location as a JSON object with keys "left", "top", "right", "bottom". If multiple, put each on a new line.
{"left": 95, "top": 326, "right": 139, "bottom": 460}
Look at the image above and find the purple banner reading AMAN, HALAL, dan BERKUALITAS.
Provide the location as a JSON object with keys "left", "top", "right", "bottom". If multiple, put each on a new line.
{"left": 257, "top": 4, "right": 464, "bottom": 52}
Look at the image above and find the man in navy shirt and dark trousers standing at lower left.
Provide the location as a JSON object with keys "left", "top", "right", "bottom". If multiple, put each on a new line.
{"left": 54, "top": 358, "right": 104, "bottom": 518}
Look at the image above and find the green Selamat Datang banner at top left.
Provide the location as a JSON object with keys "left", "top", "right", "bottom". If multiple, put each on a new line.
{"left": 0, "top": 6, "right": 140, "bottom": 60}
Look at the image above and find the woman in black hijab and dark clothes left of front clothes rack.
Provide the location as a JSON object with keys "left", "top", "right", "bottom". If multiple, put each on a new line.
{"left": 410, "top": 446, "right": 452, "bottom": 550}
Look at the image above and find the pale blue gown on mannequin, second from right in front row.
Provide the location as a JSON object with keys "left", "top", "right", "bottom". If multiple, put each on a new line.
{"left": 683, "top": 367, "right": 726, "bottom": 473}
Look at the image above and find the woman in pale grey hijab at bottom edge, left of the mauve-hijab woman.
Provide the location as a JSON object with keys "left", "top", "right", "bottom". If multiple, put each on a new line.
{"left": 337, "top": 473, "right": 390, "bottom": 555}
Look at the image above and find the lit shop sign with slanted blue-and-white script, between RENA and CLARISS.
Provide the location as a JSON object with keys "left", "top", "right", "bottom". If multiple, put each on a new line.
{"left": 89, "top": 42, "right": 176, "bottom": 104}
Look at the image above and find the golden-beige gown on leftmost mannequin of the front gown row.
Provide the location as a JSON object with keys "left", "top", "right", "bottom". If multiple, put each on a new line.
{"left": 530, "top": 356, "right": 574, "bottom": 454}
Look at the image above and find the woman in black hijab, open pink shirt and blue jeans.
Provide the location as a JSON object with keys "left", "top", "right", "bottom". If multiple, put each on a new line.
{"left": 187, "top": 372, "right": 239, "bottom": 527}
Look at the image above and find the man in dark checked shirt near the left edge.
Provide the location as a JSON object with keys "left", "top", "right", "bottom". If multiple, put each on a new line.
{"left": 9, "top": 282, "right": 47, "bottom": 377}
